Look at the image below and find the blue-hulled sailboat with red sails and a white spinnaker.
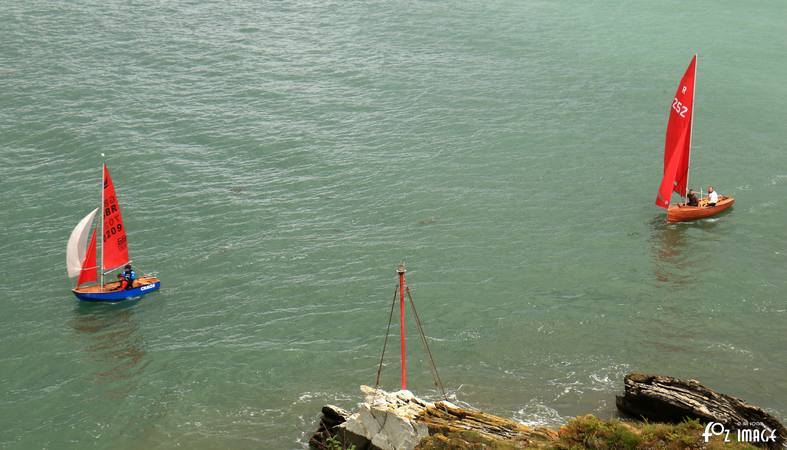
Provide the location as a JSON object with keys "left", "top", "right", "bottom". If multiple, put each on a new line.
{"left": 66, "top": 164, "right": 161, "bottom": 302}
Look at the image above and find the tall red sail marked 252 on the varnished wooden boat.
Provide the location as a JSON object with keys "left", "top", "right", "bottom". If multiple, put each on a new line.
{"left": 656, "top": 55, "right": 697, "bottom": 207}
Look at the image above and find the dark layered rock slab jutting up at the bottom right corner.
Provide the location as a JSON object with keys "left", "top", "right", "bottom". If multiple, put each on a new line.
{"left": 616, "top": 373, "right": 787, "bottom": 448}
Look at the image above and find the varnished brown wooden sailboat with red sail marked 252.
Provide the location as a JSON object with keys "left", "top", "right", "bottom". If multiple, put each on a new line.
{"left": 656, "top": 54, "right": 735, "bottom": 223}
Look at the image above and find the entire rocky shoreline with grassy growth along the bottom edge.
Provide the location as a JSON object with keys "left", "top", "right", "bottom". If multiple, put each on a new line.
{"left": 309, "top": 374, "right": 787, "bottom": 450}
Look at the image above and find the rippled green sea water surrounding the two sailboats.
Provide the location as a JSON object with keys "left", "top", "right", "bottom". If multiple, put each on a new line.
{"left": 0, "top": 0, "right": 787, "bottom": 449}
